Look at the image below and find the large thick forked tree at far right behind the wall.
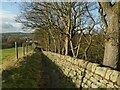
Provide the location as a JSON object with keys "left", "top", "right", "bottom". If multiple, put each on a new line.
{"left": 98, "top": 0, "right": 120, "bottom": 70}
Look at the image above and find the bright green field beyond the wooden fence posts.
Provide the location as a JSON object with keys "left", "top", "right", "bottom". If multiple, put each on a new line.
{"left": 2, "top": 47, "right": 22, "bottom": 62}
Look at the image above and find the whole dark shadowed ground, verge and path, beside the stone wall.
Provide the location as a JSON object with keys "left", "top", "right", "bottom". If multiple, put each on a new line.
{"left": 2, "top": 52, "right": 75, "bottom": 89}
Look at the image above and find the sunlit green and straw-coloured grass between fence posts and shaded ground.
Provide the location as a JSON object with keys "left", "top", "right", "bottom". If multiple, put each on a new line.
{"left": 0, "top": 47, "right": 33, "bottom": 70}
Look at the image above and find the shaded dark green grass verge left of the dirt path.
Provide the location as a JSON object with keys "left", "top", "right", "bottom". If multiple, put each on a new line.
{"left": 2, "top": 54, "right": 42, "bottom": 88}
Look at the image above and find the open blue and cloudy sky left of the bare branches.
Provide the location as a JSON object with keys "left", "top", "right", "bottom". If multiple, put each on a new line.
{"left": 0, "top": 2, "right": 32, "bottom": 33}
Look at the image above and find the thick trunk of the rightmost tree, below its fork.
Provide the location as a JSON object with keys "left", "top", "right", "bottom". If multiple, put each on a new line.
{"left": 103, "top": 14, "right": 120, "bottom": 68}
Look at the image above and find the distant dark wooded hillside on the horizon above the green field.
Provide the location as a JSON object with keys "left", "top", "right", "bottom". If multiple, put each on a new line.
{"left": 0, "top": 32, "right": 34, "bottom": 48}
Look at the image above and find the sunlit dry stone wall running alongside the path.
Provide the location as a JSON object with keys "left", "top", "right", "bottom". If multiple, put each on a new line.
{"left": 43, "top": 51, "right": 120, "bottom": 88}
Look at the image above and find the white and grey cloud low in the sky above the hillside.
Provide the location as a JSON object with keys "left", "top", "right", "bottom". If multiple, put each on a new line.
{"left": 0, "top": 11, "right": 22, "bottom": 33}
